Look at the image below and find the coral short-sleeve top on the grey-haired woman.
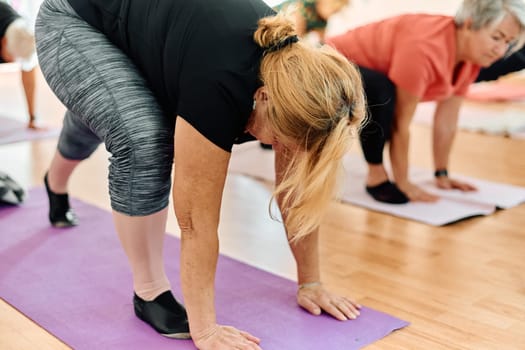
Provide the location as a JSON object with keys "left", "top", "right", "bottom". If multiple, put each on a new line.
{"left": 327, "top": 14, "right": 480, "bottom": 101}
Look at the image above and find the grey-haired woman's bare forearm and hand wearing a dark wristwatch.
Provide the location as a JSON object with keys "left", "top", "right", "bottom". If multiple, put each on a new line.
{"left": 432, "top": 96, "right": 475, "bottom": 191}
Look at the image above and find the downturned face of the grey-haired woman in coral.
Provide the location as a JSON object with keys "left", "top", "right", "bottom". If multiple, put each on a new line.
{"left": 466, "top": 14, "right": 521, "bottom": 67}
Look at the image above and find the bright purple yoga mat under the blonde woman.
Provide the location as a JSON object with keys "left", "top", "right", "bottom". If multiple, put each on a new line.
{"left": 0, "top": 188, "right": 408, "bottom": 350}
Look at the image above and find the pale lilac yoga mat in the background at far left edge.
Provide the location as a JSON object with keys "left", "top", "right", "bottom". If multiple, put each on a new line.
{"left": 0, "top": 117, "right": 60, "bottom": 145}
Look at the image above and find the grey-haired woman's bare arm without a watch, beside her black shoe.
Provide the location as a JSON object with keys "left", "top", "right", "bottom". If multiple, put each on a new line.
{"left": 390, "top": 87, "right": 437, "bottom": 201}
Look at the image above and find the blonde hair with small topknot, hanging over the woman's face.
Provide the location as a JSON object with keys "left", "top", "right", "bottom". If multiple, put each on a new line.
{"left": 254, "top": 14, "right": 365, "bottom": 239}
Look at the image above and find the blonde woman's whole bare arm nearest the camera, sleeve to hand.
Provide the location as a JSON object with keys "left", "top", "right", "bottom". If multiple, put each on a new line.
{"left": 173, "top": 117, "right": 259, "bottom": 350}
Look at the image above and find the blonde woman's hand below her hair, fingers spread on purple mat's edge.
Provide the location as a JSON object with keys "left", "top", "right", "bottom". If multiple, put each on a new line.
{"left": 297, "top": 284, "right": 361, "bottom": 321}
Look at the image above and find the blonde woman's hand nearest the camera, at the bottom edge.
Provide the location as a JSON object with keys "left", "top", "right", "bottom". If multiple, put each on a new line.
{"left": 191, "top": 325, "right": 261, "bottom": 350}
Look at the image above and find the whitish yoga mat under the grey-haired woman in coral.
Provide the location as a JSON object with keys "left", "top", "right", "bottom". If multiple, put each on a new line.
{"left": 229, "top": 142, "right": 525, "bottom": 226}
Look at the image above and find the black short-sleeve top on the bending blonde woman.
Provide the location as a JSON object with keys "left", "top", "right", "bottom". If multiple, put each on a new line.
{"left": 68, "top": 0, "right": 274, "bottom": 151}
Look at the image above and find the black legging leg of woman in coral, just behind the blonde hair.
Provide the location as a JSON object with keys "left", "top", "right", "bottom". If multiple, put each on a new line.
{"left": 359, "top": 67, "right": 396, "bottom": 164}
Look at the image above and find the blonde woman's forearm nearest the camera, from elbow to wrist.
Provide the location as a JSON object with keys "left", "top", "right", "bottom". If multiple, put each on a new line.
{"left": 180, "top": 230, "right": 219, "bottom": 334}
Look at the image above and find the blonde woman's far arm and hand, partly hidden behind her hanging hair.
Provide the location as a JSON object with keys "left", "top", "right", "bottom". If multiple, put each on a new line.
{"left": 274, "top": 146, "right": 361, "bottom": 321}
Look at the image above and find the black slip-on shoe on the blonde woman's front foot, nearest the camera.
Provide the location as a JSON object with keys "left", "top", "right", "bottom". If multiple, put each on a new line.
{"left": 133, "top": 290, "right": 190, "bottom": 339}
